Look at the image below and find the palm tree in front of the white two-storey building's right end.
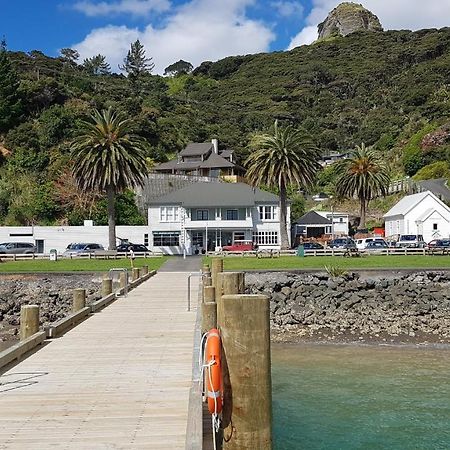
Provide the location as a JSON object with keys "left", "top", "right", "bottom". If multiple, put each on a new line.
{"left": 245, "top": 121, "right": 320, "bottom": 249}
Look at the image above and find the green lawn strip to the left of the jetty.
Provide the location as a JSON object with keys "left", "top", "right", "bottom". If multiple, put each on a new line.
{"left": 0, "top": 256, "right": 167, "bottom": 273}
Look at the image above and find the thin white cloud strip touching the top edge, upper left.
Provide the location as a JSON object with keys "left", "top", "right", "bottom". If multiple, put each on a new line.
{"left": 73, "top": 0, "right": 170, "bottom": 17}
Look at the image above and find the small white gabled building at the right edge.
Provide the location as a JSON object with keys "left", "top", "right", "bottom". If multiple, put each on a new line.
{"left": 384, "top": 191, "right": 450, "bottom": 242}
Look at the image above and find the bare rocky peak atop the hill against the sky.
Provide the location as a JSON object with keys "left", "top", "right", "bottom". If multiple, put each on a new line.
{"left": 318, "top": 2, "right": 383, "bottom": 40}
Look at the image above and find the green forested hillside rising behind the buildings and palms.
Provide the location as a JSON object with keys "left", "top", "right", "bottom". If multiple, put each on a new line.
{"left": 0, "top": 29, "right": 450, "bottom": 224}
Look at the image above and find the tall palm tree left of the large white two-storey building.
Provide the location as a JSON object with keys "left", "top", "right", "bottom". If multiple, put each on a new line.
{"left": 72, "top": 108, "right": 148, "bottom": 250}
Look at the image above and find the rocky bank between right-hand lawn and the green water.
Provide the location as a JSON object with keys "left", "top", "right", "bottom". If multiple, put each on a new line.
{"left": 246, "top": 272, "right": 450, "bottom": 344}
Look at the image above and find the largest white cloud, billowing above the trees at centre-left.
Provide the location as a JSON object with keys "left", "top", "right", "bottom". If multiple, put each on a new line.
{"left": 72, "top": 0, "right": 275, "bottom": 73}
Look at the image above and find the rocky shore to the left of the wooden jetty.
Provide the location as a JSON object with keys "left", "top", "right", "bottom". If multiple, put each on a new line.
{"left": 0, "top": 274, "right": 101, "bottom": 341}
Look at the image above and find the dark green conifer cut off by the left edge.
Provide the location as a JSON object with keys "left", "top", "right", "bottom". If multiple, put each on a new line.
{"left": 0, "top": 40, "right": 22, "bottom": 133}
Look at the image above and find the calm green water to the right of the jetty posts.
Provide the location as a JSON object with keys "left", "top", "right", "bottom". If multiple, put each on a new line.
{"left": 272, "top": 345, "right": 450, "bottom": 450}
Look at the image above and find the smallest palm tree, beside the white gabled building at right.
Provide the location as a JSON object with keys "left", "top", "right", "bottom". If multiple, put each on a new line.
{"left": 335, "top": 143, "right": 390, "bottom": 228}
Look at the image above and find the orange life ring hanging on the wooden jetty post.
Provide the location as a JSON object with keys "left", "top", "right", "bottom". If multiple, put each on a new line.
{"left": 205, "top": 328, "right": 222, "bottom": 414}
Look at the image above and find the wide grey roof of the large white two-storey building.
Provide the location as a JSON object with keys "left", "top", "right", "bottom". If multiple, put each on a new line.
{"left": 150, "top": 183, "right": 279, "bottom": 208}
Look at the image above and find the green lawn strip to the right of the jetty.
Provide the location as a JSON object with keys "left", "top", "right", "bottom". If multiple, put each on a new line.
{"left": 205, "top": 255, "right": 450, "bottom": 270}
